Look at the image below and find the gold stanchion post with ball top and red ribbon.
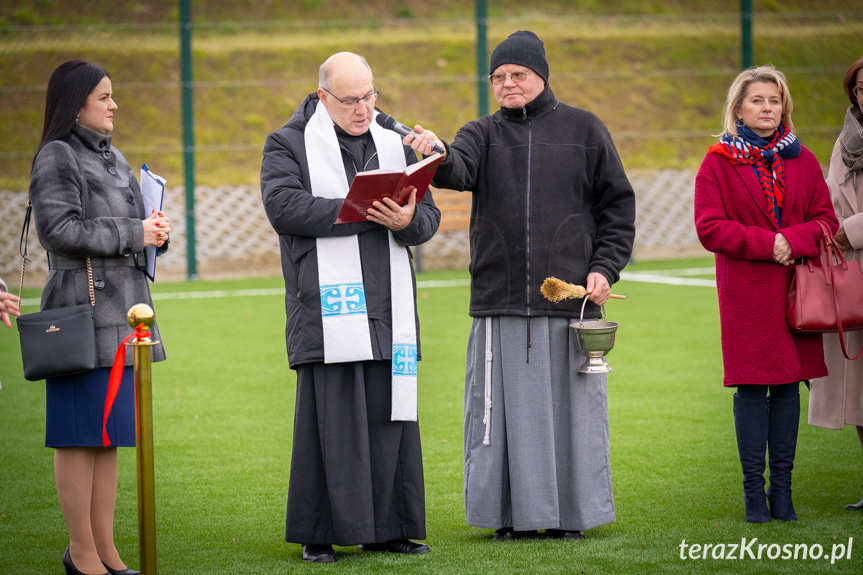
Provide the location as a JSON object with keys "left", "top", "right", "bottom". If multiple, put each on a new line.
{"left": 126, "top": 303, "right": 159, "bottom": 575}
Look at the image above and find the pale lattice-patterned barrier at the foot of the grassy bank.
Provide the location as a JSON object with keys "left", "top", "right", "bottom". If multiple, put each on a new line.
{"left": 0, "top": 170, "right": 707, "bottom": 286}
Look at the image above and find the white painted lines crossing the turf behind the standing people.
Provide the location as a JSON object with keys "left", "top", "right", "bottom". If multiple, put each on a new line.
{"left": 21, "top": 268, "right": 716, "bottom": 306}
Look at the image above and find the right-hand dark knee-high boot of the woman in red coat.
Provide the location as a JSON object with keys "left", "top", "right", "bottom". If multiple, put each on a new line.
{"left": 767, "top": 395, "right": 800, "bottom": 521}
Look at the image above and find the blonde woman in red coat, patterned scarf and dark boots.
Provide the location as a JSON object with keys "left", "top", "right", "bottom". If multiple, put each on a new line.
{"left": 695, "top": 66, "right": 839, "bottom": 523}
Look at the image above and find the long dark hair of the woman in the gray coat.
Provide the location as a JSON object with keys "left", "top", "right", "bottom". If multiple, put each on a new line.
{"left": 31, "top": 60, "right": 111, "bottom": 169}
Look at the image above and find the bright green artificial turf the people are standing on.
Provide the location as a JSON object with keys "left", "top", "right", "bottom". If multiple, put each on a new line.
{"left": 0, "top": 259, "right": 863, "bottom": 574}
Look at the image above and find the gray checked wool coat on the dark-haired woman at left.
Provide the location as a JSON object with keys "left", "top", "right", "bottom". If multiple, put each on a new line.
{"left": 30, "top": 124, "right": 170, "bottom": 368}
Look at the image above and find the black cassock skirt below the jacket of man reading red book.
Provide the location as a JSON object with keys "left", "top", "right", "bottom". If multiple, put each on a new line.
{"left": 285, "top": 361, "right": 425, "bottom": 546}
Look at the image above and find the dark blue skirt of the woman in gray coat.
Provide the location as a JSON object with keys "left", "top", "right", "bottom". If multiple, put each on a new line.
{"left": 45, "top": 366, "right": 136, "bottom": 447}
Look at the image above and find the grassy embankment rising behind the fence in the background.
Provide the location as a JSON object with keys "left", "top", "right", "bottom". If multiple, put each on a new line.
{"left": 0, "top": 1, "right": 861, "bottom": 190}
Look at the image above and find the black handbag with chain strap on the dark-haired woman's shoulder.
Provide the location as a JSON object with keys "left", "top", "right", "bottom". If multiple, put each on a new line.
{"left": 16, "top": 142, "right": 98, "bottom": 381}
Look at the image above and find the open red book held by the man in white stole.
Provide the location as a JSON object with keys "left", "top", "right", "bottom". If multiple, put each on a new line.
{"left": 335, "top": 154, "right": 443, "bottom": 224}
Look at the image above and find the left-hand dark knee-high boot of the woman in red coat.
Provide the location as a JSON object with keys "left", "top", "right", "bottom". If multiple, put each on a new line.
{"left": 734, "top": 393, "right": 770, "bottom": 523}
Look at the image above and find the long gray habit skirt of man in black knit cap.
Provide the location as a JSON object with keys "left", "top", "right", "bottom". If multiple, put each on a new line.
{"left": 464, "top": 316, "right": 615, "bottom": 531}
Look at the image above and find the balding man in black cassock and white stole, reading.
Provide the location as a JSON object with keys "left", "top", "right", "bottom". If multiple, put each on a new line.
{"left": 261, "top": 52, "right": 440, "bottom": 563}
